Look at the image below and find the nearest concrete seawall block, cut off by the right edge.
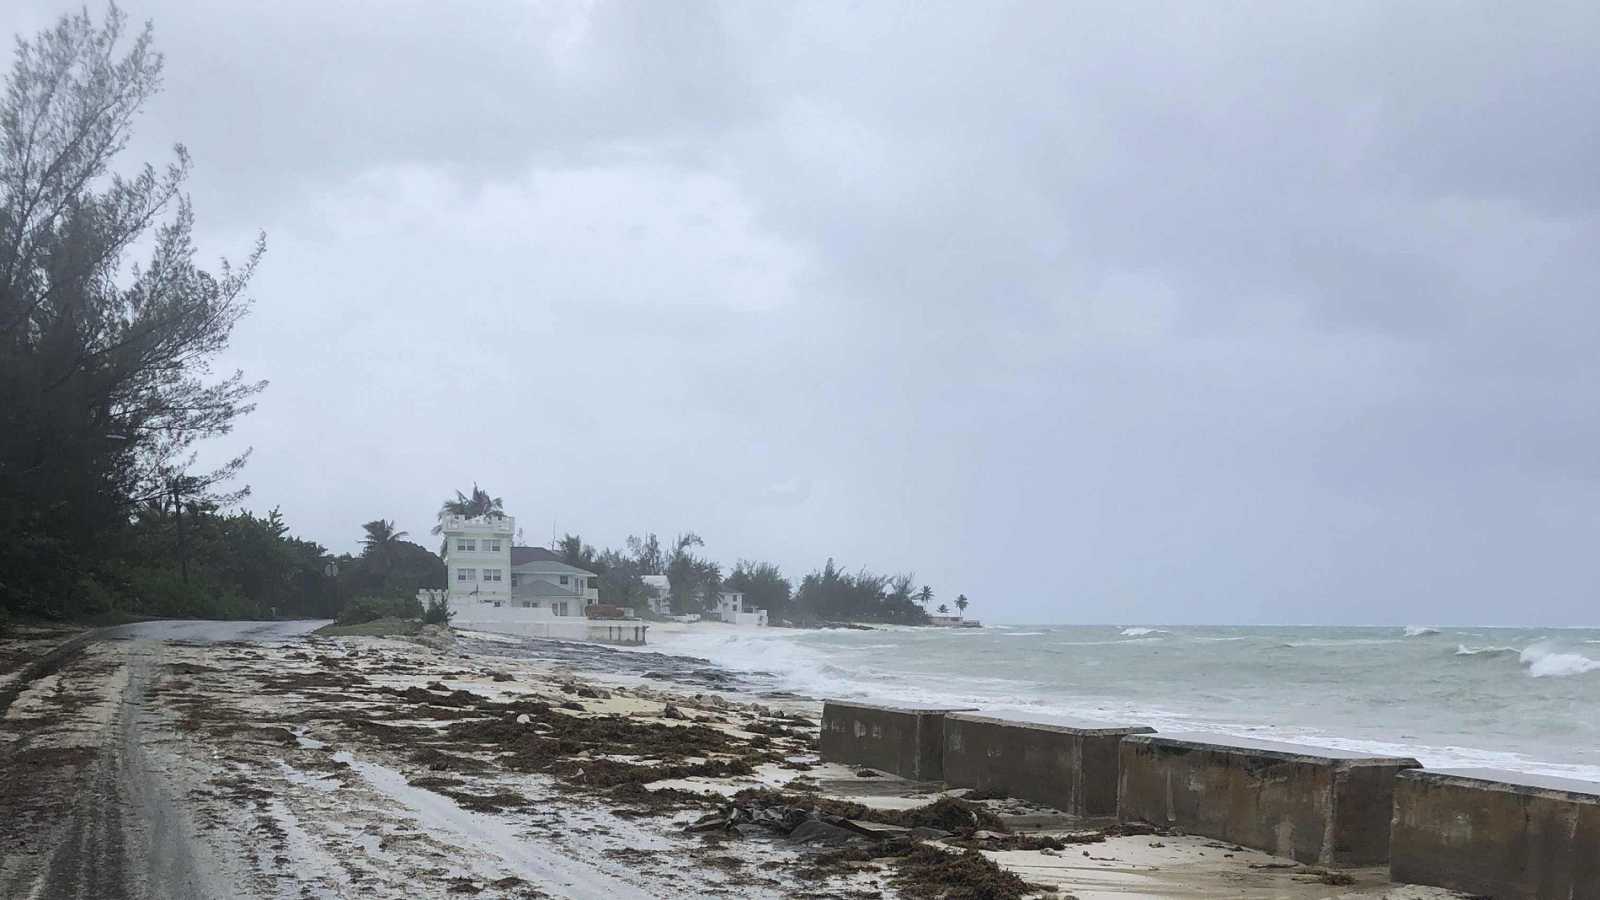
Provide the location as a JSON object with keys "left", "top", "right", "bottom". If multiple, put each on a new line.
{"left": 1389, "top": 769, "right": 1600, "bottom": 900}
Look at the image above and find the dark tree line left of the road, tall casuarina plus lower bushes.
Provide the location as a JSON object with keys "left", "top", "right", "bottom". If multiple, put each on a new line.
{"left": 0, "top": 14, "right": 443, "bottom": 621}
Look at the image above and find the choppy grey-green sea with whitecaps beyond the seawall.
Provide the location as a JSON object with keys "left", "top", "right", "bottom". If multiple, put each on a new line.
{"left": 651, "top": 626, "right": 1600, "bottom": 781}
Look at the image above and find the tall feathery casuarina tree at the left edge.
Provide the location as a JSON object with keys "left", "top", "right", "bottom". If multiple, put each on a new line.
{"left": 0, "top": 6, "right": 266, "bottom": 613}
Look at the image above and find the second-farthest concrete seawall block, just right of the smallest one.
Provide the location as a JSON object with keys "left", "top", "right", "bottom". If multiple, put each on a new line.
{"left": 944, "top": 713, "right": 1154, "bottom": 817}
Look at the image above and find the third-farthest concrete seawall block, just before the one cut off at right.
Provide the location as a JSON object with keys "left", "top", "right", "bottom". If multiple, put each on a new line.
{"left": 1118, "top": 735, "right": 1419, "bottom": 865}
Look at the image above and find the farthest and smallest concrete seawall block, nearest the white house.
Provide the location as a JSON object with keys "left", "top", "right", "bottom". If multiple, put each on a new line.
{"left": 821, "top": 700, "right": 962, "bottom": 781}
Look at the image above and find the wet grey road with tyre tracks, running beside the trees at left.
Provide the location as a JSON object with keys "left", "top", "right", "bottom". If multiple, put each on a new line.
{"left": 0, "top": 621, "right": 325, "bottom": 900}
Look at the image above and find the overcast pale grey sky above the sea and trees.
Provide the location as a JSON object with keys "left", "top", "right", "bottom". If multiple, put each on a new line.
{"left": 0, "top": 0, "right": 1600, "bottom": 625}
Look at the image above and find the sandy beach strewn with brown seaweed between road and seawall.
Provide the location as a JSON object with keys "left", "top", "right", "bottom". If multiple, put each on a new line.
{"left": 0, "top": 624, "right": 1472, "bottom": 900}
